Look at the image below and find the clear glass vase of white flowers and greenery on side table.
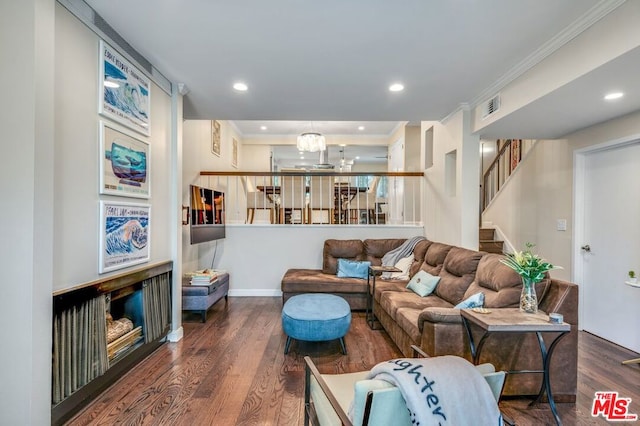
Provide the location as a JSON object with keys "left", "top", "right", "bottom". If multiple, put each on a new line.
{"left": 501, "top": 243, "right": 561, "bottom": 314}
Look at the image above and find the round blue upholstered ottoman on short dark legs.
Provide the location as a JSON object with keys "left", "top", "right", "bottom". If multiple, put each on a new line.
{"left": 282, "top": 293, "right": 351, "bottom": 355}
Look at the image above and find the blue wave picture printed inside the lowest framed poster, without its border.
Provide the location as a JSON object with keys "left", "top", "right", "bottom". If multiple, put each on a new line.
{"left": 105, "top": 217, "right": 149, "bottom": 255}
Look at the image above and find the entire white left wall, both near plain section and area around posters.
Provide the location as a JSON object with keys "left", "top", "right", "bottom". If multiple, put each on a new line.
{"left": 0, "top": 4, "right": 175, "bottom": 425}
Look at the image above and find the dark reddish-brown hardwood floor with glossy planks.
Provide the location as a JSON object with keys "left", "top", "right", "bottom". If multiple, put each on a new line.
{"left": 68, "top": 297, "right": 640, "bottom": 426}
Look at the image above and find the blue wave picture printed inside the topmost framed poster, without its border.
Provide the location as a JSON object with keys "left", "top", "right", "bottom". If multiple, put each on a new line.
{"left": 104, "top": 61, "right": 149, "bottom": 123}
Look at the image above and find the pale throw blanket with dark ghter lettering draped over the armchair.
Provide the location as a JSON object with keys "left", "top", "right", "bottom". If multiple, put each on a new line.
{"left": 367, "top": 355, "right": 502, "bottom": 426}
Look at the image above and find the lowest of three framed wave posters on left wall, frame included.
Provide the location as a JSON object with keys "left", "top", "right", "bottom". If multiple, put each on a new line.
{"left": 98, "top": 201, "right": 151, "bottom": 274}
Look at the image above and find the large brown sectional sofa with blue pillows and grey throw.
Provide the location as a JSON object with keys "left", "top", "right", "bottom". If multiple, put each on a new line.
{"left": 282, "top": 239, "right": 578, "bottom": 402}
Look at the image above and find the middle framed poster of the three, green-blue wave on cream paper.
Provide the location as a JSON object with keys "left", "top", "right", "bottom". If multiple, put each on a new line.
{"left": 100, "top": 120, "right": 150, "bottom": 198}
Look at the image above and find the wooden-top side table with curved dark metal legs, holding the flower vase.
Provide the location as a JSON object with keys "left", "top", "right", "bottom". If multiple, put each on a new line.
{"left": 460, "top": 308, "right": 571, "bottom": 425}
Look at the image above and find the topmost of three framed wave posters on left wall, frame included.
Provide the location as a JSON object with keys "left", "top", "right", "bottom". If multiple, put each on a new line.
{"left": 98, "top": 40, "right": 151, "bottom": 136}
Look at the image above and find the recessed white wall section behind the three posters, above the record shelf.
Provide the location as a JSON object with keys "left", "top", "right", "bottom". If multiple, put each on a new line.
{"left": 54, "top": 5, "right": 173, "bottom": 290}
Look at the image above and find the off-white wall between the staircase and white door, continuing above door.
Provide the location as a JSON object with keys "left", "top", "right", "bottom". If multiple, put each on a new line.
{"left": 483, "top": 112, "right": 640, "bottom": 280}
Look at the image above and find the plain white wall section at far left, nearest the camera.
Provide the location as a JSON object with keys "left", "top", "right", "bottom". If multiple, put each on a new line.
{"left": 0, "top": 0, "right": 55, "bottom": 425}
